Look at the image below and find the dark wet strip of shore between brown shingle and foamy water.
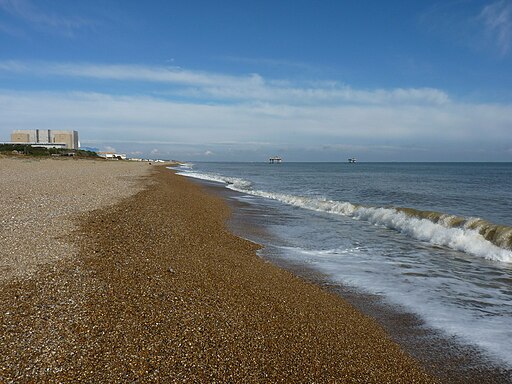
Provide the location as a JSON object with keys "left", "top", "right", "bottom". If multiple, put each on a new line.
{"left": 190, "top": 179, "right": 512, "bottom": 383}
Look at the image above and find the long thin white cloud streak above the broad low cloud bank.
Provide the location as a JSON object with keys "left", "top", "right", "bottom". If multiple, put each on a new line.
{"left": 0, "top": 61, "right": 450, "bottom": 105}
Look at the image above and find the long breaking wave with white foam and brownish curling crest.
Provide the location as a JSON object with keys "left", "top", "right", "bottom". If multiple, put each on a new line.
{"left": 178, "top": 169, "right": 512, "bottom": 263}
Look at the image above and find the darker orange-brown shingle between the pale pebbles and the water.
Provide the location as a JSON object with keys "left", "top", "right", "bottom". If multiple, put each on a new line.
{"left": 0, "top": 158, "right": 440, "bottom": 383}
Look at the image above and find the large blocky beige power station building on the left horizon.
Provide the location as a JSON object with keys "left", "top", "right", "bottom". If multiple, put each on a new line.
{"left": 11, "top": 129, "right": 79, "bottom": 149}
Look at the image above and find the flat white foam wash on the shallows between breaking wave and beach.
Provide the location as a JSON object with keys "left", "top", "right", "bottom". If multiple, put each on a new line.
{"left": 278, "top": 246, "right": 512, "bottom": 367}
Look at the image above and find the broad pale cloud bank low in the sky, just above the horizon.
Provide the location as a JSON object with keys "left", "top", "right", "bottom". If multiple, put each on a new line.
{"left": 0, "top": 91, "right": 512, "bottom": 145}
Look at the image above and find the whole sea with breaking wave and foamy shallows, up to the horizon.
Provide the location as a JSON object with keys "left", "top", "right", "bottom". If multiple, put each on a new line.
{"left": 173, "top": 162, "right": 512, "bottom": 368}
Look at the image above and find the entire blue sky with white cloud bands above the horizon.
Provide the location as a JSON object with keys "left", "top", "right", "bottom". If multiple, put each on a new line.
{"left": 0, "top": 0, "right": 512, "bottom": 161}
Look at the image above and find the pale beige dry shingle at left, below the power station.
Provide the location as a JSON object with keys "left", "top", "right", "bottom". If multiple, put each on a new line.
{"left": 0, "top": 157, "right": 150, "bottom": 282}
